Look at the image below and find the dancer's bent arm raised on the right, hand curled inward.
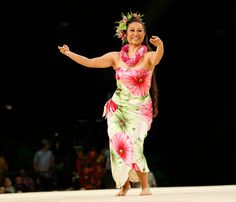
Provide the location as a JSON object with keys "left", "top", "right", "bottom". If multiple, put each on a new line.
{"left": 150, "top": 36, "right": 164, "bottom": 65}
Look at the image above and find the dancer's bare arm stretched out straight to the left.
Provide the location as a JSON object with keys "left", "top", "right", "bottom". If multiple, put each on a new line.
{"left": 58, "top": 45, "right": 114, "bottom": 68}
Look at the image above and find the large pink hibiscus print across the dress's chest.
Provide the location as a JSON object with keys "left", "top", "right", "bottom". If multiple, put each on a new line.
{"left": 123, "top": 69, "right": 151, "bottom": 96}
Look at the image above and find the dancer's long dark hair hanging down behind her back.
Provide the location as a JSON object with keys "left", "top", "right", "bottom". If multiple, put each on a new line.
{"left": 125, "top": 17, "right": 159, "bottom": 118}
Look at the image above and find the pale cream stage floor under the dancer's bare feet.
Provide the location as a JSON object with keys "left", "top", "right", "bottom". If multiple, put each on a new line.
{"left": 0, "top": 185, "right": 236, "bottom": 202}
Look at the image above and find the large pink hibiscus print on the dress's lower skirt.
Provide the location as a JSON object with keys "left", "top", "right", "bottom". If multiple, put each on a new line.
{"left": 110, "top": 132, "right": 133, "bottom": 166}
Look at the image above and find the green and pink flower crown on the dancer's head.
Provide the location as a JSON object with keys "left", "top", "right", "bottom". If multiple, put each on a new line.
{"left": 115, "top": 12, "right": 144, "bottom": 44}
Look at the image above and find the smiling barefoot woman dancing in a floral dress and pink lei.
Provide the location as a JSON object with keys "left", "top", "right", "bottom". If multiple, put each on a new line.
{"left": 58, "top": 12, "right": 164, "bottom": 196}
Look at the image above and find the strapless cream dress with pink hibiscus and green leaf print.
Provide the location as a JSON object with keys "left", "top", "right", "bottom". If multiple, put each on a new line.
{"left": 103, "top": 67, "right": 153, "bottom": 188}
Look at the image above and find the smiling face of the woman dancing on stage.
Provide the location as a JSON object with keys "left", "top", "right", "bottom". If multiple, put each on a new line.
{"left": 127, "top": 22, "right": 145, "bottom": 45}
